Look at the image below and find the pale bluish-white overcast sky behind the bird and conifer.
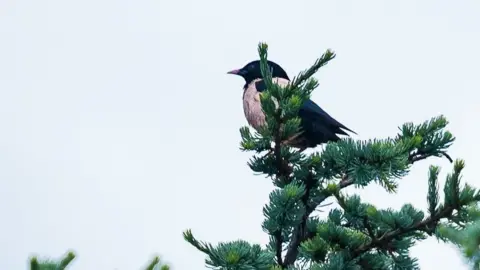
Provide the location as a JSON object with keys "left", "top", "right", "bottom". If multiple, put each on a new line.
{"left": 0, "top": 0, "right": 480, "bottom": 269}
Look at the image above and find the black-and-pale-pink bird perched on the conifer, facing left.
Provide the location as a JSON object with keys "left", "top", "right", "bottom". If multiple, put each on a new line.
{"left": 227, "top": 60, "right": 357, "bottom": 152}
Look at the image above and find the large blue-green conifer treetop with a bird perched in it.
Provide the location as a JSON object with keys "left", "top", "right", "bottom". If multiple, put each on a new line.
{"left": 184, "top": 43, "right": 480, "bottom": 270}
